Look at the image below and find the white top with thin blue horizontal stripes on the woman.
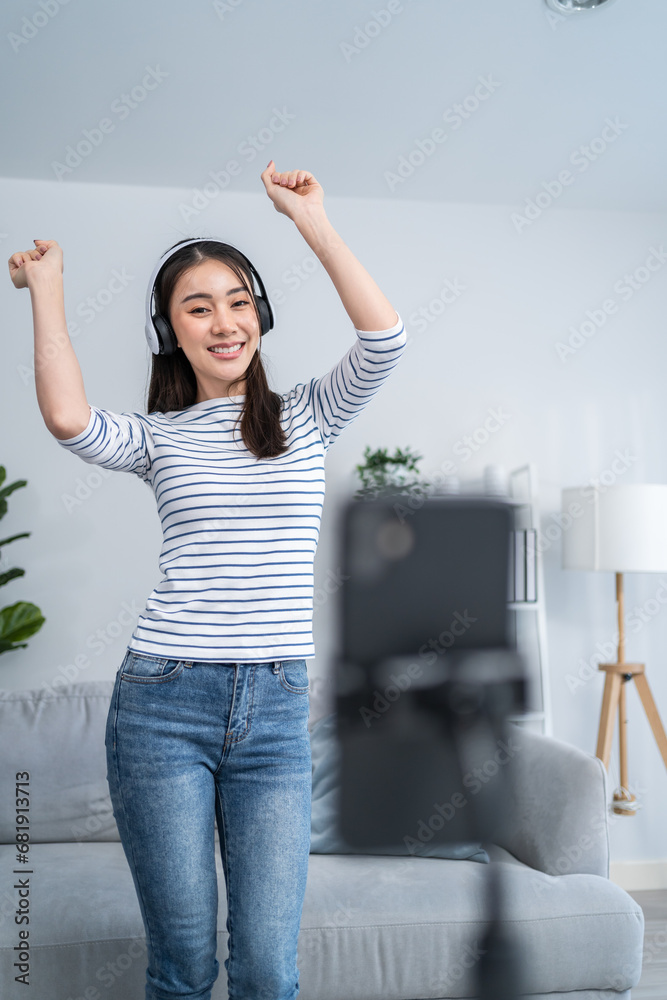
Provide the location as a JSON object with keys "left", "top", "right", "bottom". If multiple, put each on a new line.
{"left": 56, "top": 314, "right": 407, "bottom": 663}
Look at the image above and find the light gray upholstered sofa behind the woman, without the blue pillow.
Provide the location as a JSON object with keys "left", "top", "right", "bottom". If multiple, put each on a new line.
{"left": 0, "top": 681, "right": 643, "bottom": 1000}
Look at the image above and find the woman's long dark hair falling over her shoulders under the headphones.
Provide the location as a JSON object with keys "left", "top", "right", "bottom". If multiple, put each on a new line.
{"left": 146, "top": 240, "right": 287, "bottom": 458}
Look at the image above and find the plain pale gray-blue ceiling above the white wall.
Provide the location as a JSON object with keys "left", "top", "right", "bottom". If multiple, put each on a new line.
{"left": 0, "top": 0, "right": 667, "bottom": 211}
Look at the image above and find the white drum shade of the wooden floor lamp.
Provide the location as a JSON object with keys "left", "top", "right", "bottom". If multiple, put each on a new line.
{"left": 561, "top": 483, "right": 667, "bottom": 573}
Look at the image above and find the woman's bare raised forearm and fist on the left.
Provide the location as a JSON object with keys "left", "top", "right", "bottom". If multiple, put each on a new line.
{"left": 9, "top": 240, "right": 91, "bottom": 439}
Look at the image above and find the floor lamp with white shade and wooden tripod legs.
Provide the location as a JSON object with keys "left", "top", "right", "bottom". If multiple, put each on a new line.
{"left": 562, "top": 483, "right": 667, "bottom": 816}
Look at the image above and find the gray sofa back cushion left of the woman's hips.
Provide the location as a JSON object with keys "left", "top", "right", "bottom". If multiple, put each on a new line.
{"left": 0, "top": 680, "right": 120, "bottom": 844}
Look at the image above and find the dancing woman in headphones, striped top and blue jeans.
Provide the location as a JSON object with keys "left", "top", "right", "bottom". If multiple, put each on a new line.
{"left": 9, "top": 160, "right": 406, "bottom": 1000}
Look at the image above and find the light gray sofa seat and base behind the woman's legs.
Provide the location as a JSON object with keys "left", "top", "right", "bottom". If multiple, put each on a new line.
{"left": 0, "top": 842, "right": 643, "bottom": 1000}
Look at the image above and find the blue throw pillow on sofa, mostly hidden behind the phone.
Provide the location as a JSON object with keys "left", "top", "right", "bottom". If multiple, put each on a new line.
{"left": 310, "top": 712, "right": 489, "bottom": 862}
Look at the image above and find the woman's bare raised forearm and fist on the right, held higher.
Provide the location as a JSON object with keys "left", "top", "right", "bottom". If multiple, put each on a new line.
{"left": 262, "top": 160, "right": 398, "bottom": 330}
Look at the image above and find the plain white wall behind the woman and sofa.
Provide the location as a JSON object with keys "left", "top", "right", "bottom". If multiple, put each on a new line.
{"left": 0, "top": 178, "right": 667, "bottom": 862}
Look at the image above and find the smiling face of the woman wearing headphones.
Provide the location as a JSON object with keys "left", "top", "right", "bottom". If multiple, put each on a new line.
{"left": 169, "top": 260, "right": 260, "bottom": 403}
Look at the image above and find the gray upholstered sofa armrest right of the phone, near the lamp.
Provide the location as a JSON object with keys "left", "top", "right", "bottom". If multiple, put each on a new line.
{"left": 497, "top": 726, "right": 609, "bottom": 878}
